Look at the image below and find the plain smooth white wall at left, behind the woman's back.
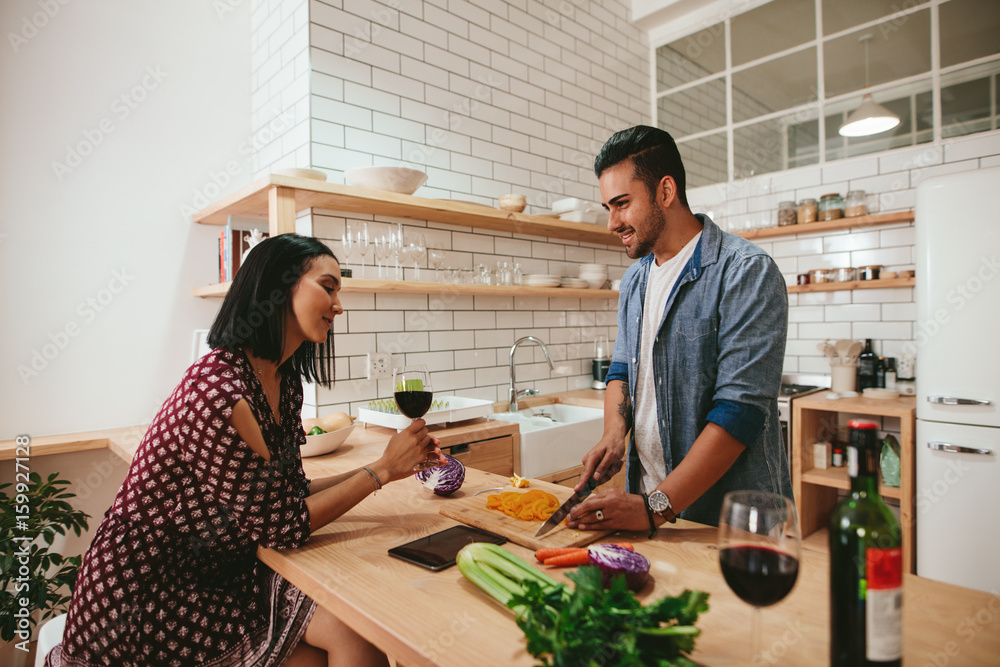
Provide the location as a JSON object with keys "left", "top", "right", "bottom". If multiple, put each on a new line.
{"left": 0, "top": 0, "right": 252, "bottom": 439}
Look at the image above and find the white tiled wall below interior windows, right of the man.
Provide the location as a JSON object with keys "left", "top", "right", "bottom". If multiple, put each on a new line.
{"left": 688, "top": 132, "right": 1000, "bottom": 375}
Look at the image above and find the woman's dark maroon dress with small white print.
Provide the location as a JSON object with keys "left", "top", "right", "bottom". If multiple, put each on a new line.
{"left": 46, "top": 349, "right": 316, "bottom": 667}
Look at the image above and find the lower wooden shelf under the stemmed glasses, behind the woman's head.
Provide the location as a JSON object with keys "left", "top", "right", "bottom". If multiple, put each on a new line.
{"left": 194, "top": 278, "right": 618, "bottom": 300}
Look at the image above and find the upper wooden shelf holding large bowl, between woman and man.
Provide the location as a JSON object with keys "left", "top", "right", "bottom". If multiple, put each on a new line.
{"left": 192, "top": 174, "right": 621, "bottom": 247}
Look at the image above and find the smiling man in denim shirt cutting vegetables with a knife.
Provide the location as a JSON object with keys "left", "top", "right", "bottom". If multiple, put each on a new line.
{"left": 569, "top": 125, "right": 791, "bottom": 536}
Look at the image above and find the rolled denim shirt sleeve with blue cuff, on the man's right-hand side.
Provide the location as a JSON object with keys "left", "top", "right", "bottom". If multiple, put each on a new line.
{"left": 707, "top": 253, "right": 788, "bottom": 447}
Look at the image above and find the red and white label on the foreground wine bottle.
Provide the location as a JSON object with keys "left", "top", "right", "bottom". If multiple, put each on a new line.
{"left": 865, "top": 547, "right": 903, "bottom": 662}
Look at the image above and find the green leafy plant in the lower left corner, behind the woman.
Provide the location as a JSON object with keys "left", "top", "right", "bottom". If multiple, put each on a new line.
{"left": 0, "top": 472, "right": 90, "bottom": 650}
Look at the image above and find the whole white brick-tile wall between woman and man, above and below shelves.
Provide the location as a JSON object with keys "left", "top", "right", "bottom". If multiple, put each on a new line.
{"left": 246, "top": 0, "right": 649, "bottom": 414}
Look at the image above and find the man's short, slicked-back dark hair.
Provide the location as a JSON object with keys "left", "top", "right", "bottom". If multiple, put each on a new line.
{"left": 594, "top": 125, "right": 688, "bottom": 208}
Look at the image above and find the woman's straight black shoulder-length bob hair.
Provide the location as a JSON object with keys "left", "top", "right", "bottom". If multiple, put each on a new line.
{"left": 208, "top": 234, "right": 337, "bottom": 387}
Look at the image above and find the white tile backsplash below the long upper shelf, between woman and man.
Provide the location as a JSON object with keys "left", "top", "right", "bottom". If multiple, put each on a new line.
{"left": 304, "top": 210, "right": 631, "bottom": 416}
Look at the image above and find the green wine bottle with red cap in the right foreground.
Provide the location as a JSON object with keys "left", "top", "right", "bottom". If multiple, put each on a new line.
{"left": 830, "top": 420, "right": 903, "bottom": 667}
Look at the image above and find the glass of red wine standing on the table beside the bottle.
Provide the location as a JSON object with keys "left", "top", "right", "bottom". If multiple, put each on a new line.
{"left": 719, "top": 491, "right": 802, "bottom": 664}
